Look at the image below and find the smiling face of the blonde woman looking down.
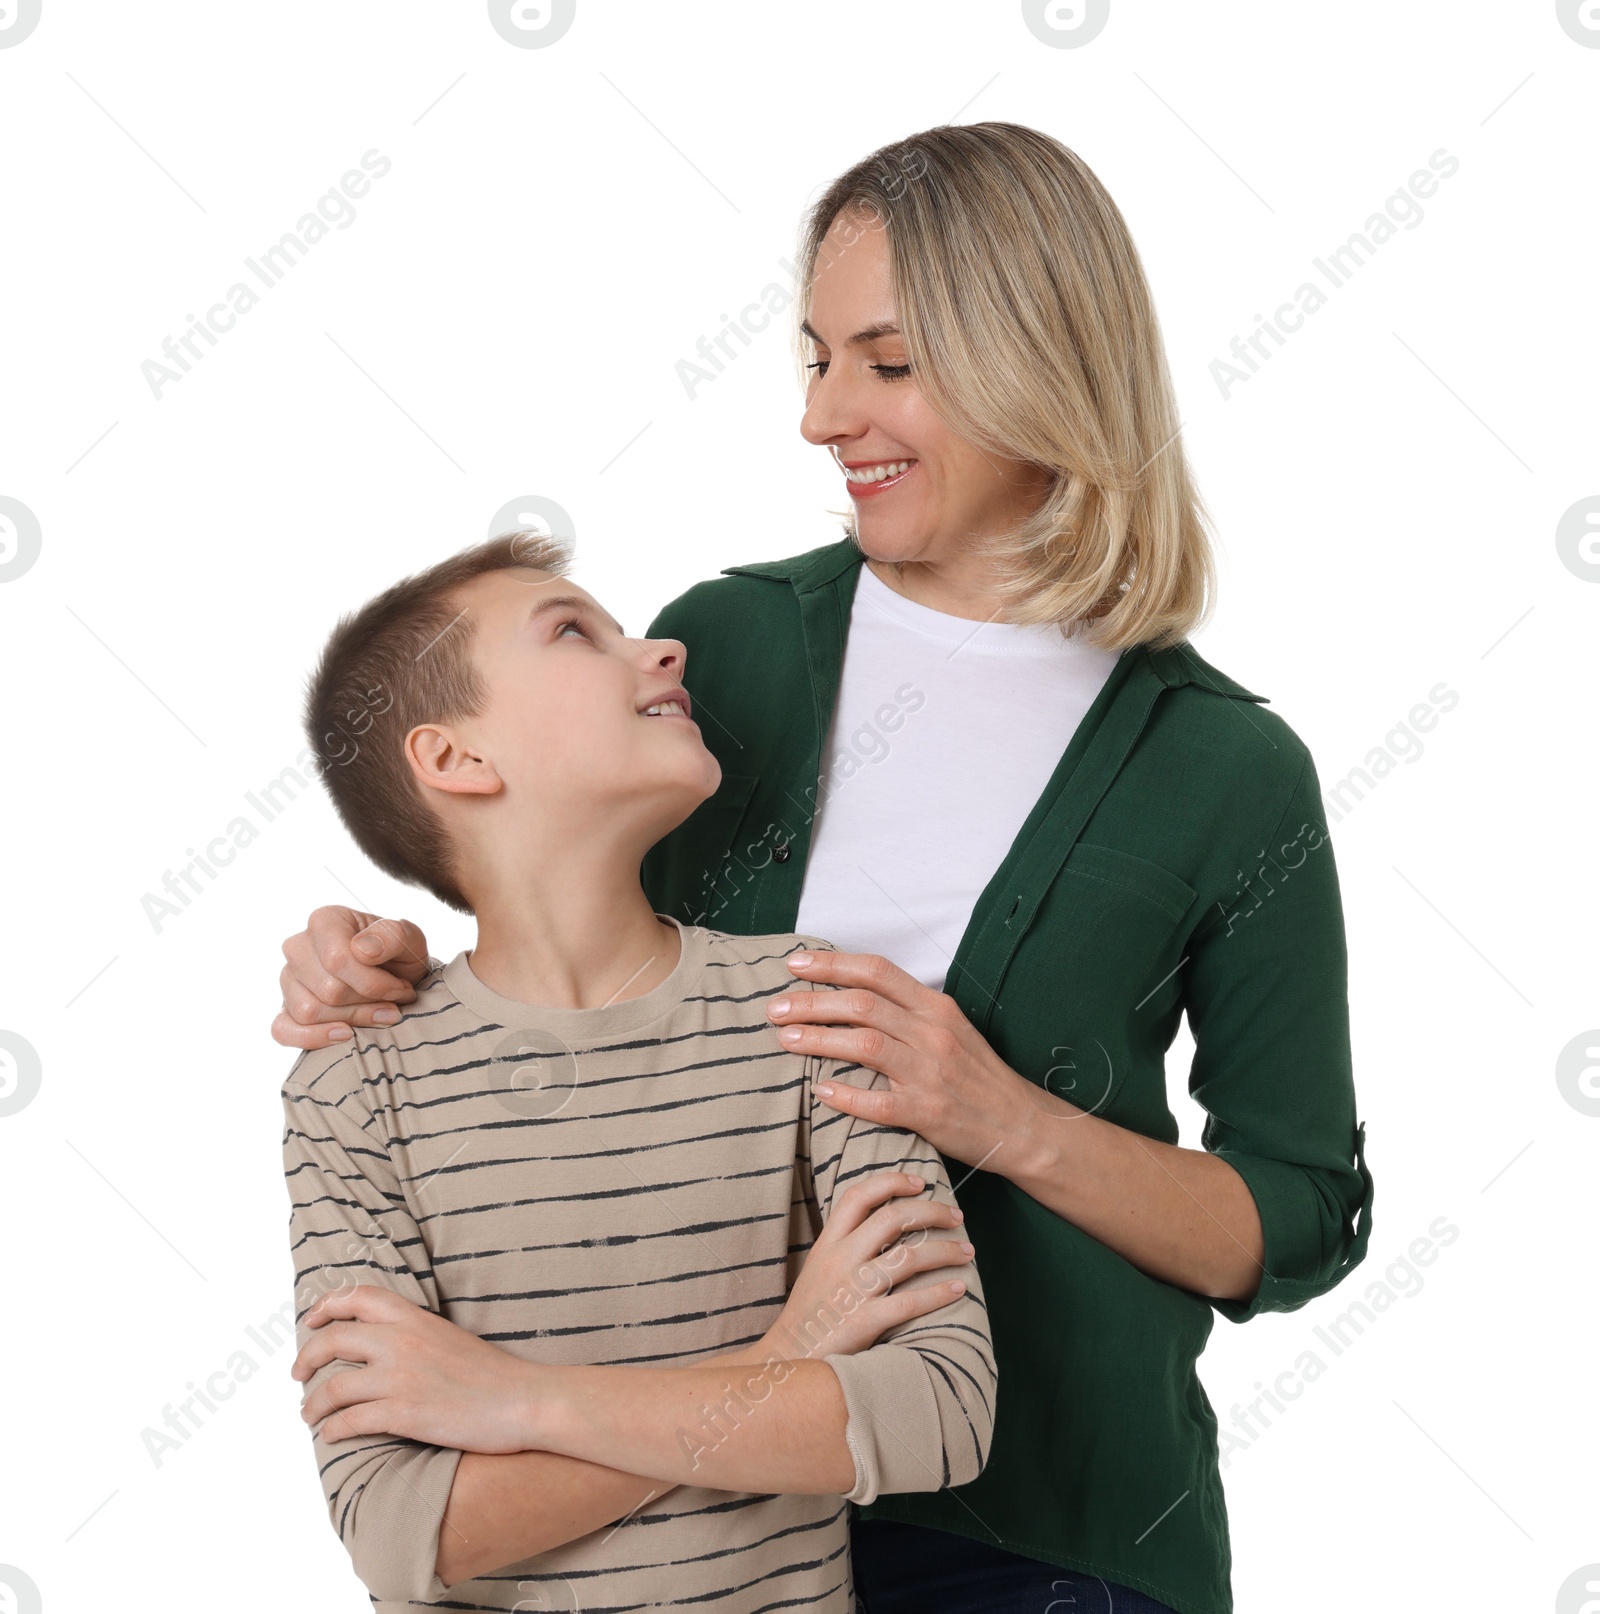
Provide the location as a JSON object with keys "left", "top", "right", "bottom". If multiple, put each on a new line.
{"left": 801, "top": 213, "right": 1051, "bottom": 565}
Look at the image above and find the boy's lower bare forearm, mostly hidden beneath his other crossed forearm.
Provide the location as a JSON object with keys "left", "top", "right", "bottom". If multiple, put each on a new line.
{"left": 434, "top": 1344, "right": 767, "bottom": 1587}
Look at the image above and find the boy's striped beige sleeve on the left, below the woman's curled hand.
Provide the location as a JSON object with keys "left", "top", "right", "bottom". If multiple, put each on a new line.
{"left": 283, "top": 1051, "right": 462, "bottom": 1608}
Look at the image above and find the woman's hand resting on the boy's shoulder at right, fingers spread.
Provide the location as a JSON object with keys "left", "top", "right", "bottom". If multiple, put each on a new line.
{"left": 767, "top": 952, "right": 1040, "bottom": 1172}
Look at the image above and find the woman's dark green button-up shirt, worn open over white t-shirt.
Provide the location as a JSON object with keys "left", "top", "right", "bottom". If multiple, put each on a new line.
{"left": 644, "top": 541, "right": 1372, "bottom": 1614}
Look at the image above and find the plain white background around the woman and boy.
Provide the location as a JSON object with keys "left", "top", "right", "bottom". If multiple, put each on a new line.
{"left": 0, "top": 0, "right": 1600, "bottom": 1614}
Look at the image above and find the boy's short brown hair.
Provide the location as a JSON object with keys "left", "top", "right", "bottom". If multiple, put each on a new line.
{"left": 305, "top": 528, "right": 572, "bottom": 914}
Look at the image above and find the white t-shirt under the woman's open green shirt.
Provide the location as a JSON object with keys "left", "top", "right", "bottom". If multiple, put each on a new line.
{"left": 794, "top": 563, "right": 1117, "bottom": 991}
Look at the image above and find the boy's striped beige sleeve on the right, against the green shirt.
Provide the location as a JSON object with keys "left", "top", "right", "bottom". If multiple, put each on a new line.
{"left": 806, "top": 987, "right": 998, "bottom": 1504}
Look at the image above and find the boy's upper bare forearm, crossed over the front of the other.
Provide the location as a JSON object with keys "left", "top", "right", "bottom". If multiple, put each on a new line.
{"left": 528, "top": 1356, "right": 856, "bottom": 1496}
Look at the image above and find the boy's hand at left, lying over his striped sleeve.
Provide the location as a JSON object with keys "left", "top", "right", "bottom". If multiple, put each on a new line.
{"left": 291, "top": 1283, "right": 538, "bottom": 1453}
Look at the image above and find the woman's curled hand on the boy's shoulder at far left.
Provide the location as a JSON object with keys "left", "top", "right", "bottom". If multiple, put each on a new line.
{"left": 273, "top": 907, "right": 428, "bottom": 1047}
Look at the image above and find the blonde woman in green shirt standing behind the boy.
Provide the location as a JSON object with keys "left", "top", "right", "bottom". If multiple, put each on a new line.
{"left": 274, "top": 124, "right": 1372, "bottom": 1614}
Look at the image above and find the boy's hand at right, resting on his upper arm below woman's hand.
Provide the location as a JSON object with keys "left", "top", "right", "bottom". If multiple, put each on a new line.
{"left": 759, "top": 1172, "right": 972, "bottom": 1361}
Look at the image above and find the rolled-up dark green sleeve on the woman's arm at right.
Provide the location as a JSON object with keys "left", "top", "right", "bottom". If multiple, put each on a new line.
{"left": 1185, "top": 755, "right": 1372, "bottom": 1322}
